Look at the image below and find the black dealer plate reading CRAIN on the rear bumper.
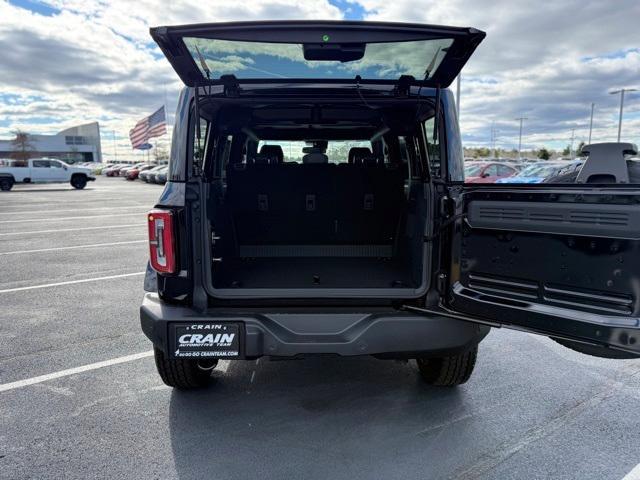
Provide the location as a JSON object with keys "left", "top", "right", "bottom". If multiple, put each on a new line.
{"left": 169, "top": 322, "right": 244, "bottom": 359}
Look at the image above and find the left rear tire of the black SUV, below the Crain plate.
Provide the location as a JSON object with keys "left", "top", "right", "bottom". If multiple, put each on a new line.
{"left": 154, "top": 348, "right": 218, "bottom": 390}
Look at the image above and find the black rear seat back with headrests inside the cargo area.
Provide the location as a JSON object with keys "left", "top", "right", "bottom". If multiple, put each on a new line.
{"left": 227, "top": 145, "right": 404, "bottom": 249}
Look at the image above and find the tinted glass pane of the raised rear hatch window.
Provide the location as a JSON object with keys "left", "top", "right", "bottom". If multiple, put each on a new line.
{"left": 184, "top": 35, "right": 453, "bottom": 79}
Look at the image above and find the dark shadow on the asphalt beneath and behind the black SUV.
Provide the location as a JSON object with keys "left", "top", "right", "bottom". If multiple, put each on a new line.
{"left": 170, "top": 357, "right": 465, "bottom": 479}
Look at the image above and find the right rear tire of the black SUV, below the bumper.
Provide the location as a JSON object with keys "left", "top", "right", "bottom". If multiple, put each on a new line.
{"left": 416, "top": 346, "right": 478, "bottom": 387}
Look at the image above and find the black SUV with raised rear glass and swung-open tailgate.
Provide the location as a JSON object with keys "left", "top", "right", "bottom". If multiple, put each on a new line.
{"left": 140, "top": 21, "right": 640, "bottom": 388}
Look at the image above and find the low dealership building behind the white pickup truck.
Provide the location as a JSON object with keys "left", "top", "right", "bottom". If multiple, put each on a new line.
{"left": 0, "top": 122, "right": 102, "bottom": 163}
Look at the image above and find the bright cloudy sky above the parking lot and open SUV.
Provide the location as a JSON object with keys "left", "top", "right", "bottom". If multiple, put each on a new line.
{"left": 0, "top": 0, "right": 640, "bottom": 160}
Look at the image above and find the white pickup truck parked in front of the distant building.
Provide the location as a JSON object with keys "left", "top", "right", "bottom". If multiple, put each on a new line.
{"left": 0, "top": 158, "right": 95, "bottom": 192}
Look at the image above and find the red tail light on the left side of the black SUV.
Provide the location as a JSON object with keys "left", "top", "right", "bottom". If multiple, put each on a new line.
{"left": 147, "top": 210, "right": 176, "bottom": 273}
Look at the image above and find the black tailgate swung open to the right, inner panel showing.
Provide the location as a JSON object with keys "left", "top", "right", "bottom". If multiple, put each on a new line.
{"left": 446, "top": 187, "right": 640, "bottom": 356}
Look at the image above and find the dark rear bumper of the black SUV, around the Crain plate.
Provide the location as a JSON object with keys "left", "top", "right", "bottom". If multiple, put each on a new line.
{"left": 140, "top": 293, "right": 489, "bottom": 358}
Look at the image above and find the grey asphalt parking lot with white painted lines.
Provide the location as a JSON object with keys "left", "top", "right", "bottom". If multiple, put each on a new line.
{"left": 0, "top": 174, "right": 640, "bottom": 480}
